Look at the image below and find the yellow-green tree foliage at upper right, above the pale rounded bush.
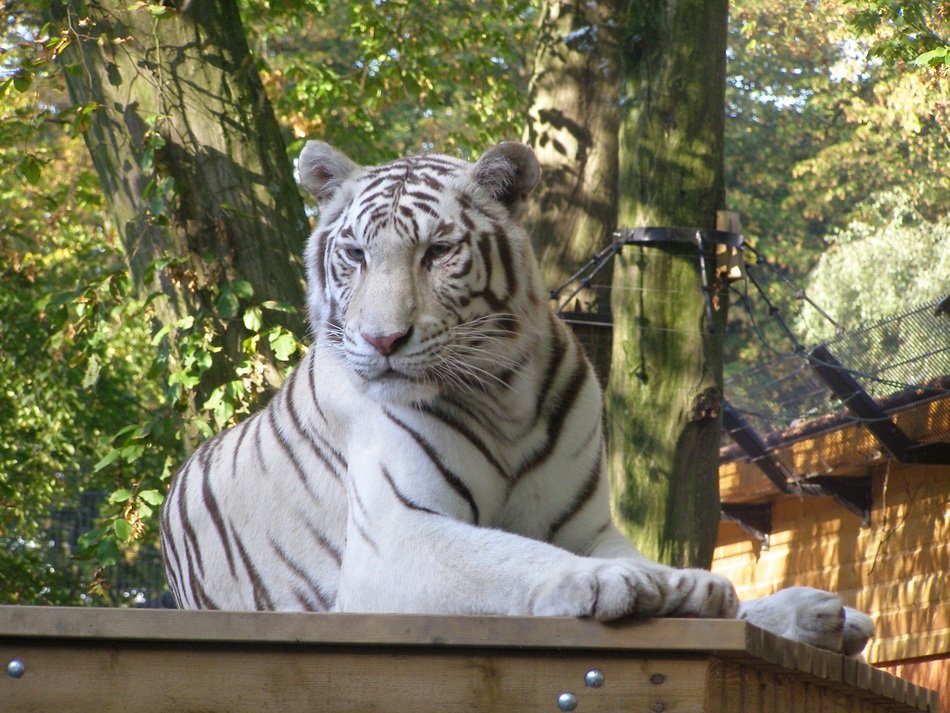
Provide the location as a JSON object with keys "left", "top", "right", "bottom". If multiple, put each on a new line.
{"left": 726, "top": 0, "right": 950, "bottom": 373}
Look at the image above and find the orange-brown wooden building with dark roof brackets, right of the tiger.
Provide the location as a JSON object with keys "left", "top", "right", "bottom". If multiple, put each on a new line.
{"left": 713, "top": 386, "right": 950, "bottom": 713}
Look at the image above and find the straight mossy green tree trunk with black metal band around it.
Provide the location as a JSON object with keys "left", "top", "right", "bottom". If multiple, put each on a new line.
{"left": 607, "top": 0, "right": 727, "bottom": 567}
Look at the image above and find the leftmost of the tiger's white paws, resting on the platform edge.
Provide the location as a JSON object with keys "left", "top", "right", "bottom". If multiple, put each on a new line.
{"left": 531, "top": 560, "right": 663, "bottom": 621}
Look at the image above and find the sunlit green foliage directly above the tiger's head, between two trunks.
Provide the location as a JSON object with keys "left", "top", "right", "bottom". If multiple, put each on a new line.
{"left": 243, "top": 0, "right": 534, "bottom": 164}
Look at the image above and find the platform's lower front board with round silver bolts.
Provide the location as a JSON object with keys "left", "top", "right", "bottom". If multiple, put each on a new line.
{"left": 0, "top": 642, "right": 706, "bottom": 713}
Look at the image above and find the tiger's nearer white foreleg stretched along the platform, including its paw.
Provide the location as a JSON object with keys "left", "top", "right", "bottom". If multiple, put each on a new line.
{"left": 336, "top": 510, "right": 662, "bottom": 620}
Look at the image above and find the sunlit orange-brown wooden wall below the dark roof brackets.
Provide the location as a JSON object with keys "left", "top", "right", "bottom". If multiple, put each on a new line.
{"left": 713, "top": 462, "right": 950, "bottom": 712}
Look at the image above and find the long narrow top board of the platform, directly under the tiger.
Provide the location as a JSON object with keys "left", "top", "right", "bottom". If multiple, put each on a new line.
{"left": 0, "top": 606, "right": 754, "bottom": 653}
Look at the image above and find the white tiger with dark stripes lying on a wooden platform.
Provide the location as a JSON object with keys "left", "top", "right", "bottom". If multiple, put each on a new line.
{"left": 162, "top": 142, "right": 873, "bottom": 653}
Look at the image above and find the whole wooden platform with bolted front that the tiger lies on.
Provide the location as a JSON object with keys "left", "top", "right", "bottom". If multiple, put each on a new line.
{"left": 0, "top": 607, "right": 938, "bottom": 713}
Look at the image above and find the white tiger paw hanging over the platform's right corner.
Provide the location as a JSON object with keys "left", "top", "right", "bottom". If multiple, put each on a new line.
{"left": 739, "top": 587, "right": 874, "bottom": 656}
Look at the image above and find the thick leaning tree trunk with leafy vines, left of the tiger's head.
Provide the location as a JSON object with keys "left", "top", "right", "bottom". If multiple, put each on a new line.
{"left": 50, "top": 0, "right": 307, "bottom": 444}
